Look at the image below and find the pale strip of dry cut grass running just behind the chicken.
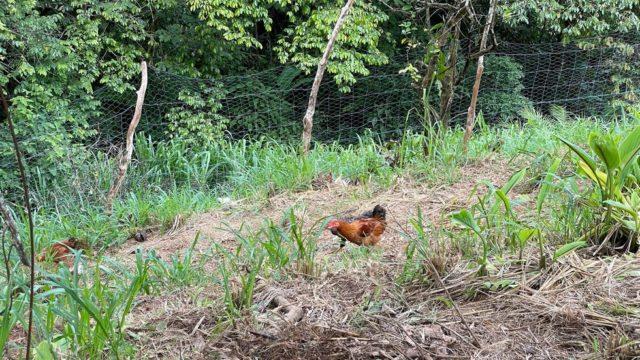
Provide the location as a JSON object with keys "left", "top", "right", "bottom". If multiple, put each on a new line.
{"left": 113, "top": 160, "right": 512, "bottom": 259}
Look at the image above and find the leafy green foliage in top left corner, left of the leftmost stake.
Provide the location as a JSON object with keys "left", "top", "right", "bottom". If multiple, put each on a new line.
{"left": 0, "top": 0, "right": 147, "bottom": 186}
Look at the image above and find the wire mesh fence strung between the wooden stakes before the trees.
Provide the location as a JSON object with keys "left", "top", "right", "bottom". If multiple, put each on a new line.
{"left": 94, "top": 35, "right": 638, "bottom": 144}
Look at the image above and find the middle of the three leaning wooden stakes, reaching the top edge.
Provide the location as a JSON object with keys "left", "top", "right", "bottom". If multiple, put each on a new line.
{"left": 302, "top": 0, "right": 355, "bottom": 154}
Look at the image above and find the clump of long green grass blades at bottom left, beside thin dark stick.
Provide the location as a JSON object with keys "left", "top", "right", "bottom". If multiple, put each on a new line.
{"left": 36, "top": 253, "right": 149, "bottom": 358}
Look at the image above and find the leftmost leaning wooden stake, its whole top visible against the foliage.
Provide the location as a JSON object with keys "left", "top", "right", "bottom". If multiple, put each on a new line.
{"left": 106, "top": 61, "right": 147, "bottom": 213}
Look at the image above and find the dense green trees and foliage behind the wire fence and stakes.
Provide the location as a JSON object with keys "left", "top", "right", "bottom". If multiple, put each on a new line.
{"left": 0, "top": 0, "right": 639, "bottom": 189}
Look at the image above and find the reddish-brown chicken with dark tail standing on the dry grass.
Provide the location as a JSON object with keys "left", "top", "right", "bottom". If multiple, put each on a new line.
{"left": 327, "top": 205, "right": 387, "bottom": 249}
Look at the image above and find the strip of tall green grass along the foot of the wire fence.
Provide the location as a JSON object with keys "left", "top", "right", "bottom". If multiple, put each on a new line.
{"left": 23, "top": 112, "right": 620, "bottom": 252}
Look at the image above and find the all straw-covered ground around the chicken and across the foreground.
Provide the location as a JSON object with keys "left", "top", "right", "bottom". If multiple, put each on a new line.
{"left": 121, "top": 160, "right": 640, "bottom": 359}
